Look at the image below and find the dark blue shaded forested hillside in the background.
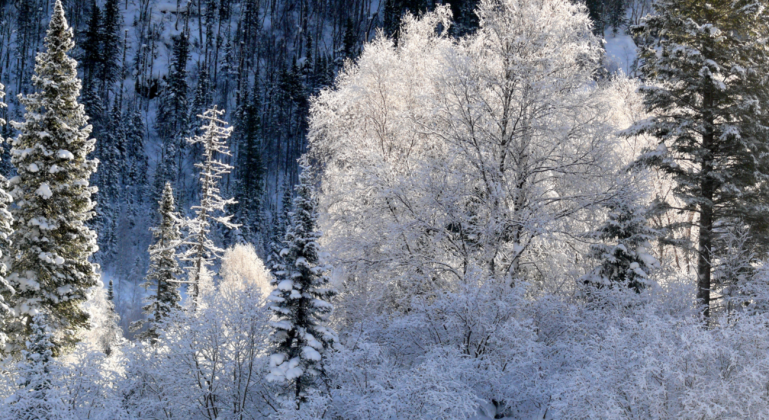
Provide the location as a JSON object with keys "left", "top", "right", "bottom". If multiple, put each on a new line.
{"left": 0, "top": 0, "right": 492, "bottom": 326}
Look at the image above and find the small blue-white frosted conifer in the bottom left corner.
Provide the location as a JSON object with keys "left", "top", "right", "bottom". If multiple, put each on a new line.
{"left": 3, "top": 314, "right": 73, "bottom": 420}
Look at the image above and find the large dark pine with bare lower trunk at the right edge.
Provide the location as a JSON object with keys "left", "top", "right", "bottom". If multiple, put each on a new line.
{"left": 626, "top": 0, "right": 769, "bottom": 316}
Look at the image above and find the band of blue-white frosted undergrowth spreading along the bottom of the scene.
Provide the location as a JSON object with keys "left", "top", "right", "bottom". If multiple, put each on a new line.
{"left": 6, "top": 281, "right": 769, "bottom": 420}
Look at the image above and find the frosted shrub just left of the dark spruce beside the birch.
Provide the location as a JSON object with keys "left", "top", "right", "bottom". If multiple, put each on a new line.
{"left": 125, "top": 272, "right": 278, "bottom": 420}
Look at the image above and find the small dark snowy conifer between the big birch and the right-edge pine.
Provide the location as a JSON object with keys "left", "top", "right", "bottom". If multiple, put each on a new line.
{"left": 583, "top": 194, "right": 659, "bottom": 292}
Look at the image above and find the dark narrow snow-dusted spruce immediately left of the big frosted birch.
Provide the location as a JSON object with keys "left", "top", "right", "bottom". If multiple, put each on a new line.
{"left": 267, "top": 165, "right": 336, "bottom": 409}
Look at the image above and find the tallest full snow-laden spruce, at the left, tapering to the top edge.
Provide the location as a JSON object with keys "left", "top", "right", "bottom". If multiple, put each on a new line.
{"left": 8, "top": 0, "right": 97, "bottom": 354}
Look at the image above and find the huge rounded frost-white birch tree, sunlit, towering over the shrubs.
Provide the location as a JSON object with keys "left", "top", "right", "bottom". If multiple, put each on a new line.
{"left": 310, "top": 0, "right": 622, "bottom": 307}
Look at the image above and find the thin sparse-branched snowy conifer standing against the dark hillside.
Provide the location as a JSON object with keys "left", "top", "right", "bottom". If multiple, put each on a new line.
{"left": 182, "top": 106, "right": 238, "bottom": 308}
